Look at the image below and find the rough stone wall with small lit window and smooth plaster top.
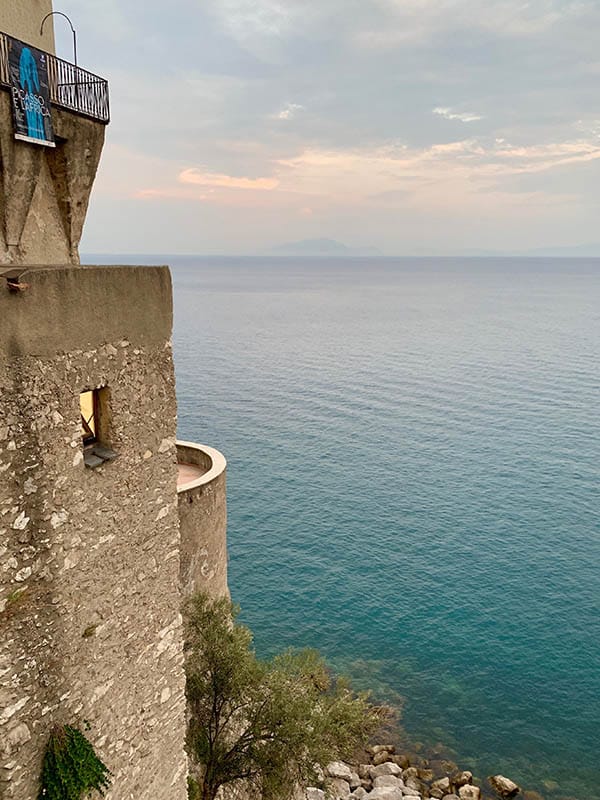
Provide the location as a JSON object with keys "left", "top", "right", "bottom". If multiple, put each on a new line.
{"left": 0, "top": 267, "right": 186, "bottom": 800}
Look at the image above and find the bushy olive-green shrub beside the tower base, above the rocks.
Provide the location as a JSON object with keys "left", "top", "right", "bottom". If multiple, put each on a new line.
{"left": 185, "top": 594, "right": 382, "bottom": 800}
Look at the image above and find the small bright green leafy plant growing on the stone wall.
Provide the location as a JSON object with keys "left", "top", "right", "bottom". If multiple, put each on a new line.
{"left": 38, "top": 725, "right": 110, "bottom": 800}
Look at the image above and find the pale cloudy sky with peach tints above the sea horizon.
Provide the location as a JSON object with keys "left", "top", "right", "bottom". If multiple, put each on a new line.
{"left": 54, "top": 0, "right": 600, "bottom": 255}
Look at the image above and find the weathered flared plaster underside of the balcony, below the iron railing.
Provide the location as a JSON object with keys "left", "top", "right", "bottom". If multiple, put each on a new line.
{"left": 0, "top": 91, "right": 106, "bottom": 265}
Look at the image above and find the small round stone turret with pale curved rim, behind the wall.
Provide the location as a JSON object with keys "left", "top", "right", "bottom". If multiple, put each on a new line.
{"left": 177, "top": 441, "right": 229, "bottom": 598}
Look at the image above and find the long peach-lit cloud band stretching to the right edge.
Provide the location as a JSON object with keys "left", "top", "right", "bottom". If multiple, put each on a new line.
{"left": 275, "top": 133, "right": 600, "bottom": 206}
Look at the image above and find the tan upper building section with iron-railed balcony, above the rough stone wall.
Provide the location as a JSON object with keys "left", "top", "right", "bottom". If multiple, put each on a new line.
{"left": 0, "top": 0, "right": 109, "bottom": 265}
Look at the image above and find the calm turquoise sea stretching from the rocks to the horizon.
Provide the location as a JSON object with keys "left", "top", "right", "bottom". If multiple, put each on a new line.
{"left": 170, "top": 259, "right": 600, "bottom": 800}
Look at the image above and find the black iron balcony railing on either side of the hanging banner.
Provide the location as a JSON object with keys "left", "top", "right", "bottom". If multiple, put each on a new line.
{"left": 0, "top": 33, "right": 110, "bottom": 124}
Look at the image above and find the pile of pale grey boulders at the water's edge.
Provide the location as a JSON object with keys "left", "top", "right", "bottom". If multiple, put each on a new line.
{"left": 305, "top": 744, "right": 542, "bottom": 800}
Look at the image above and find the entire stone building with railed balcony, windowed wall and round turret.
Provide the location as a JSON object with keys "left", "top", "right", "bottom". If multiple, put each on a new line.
{"left": 0, "top": 0, "right": 227, "bottom": 800}
